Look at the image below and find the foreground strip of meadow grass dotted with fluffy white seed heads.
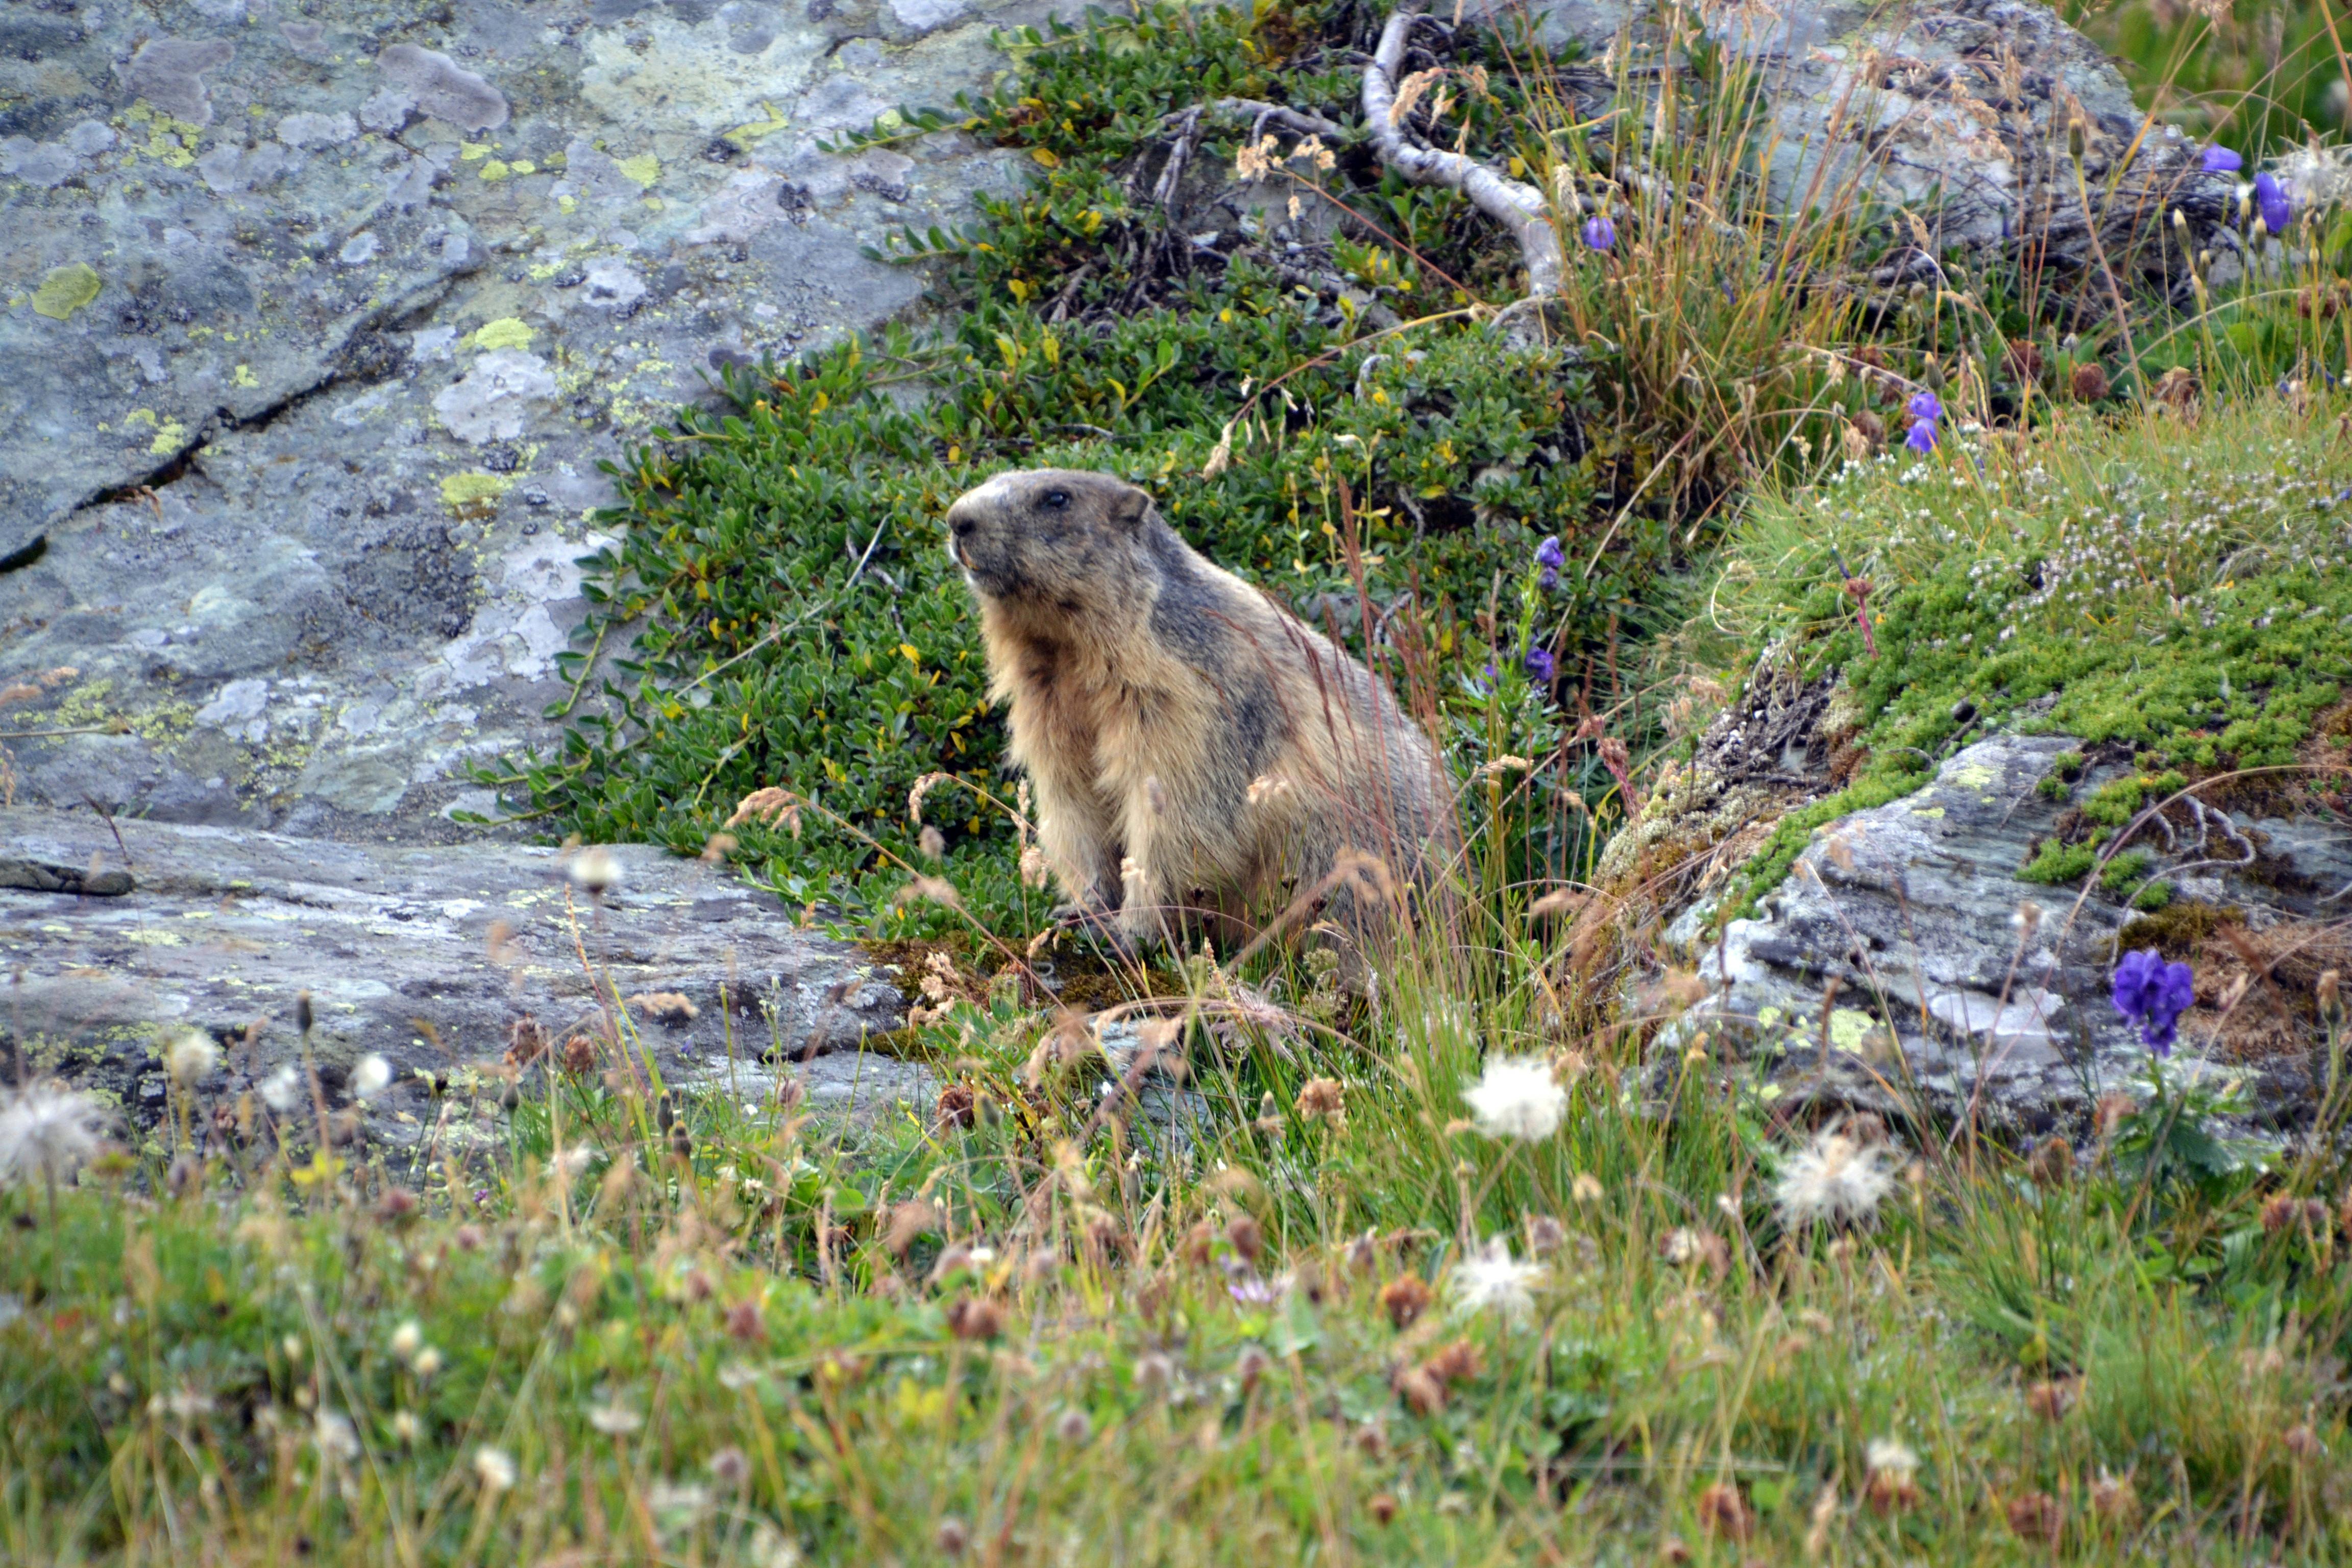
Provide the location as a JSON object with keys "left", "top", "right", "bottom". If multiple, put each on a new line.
{"left": 14, "top": 921, "right": 2352, "bottom": 1563}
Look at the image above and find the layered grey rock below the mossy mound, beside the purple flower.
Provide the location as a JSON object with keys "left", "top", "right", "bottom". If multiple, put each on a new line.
{"left": 1653, "top": 733, "right": 2352, "bottom": 1133}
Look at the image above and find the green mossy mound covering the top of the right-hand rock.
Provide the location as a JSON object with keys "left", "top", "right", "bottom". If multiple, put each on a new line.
{"left": 1705, "top": 385, "right": 2352, "bottom": 921}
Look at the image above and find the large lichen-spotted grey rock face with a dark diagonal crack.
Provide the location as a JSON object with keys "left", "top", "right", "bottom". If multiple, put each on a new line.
{"left": 0, "top": 0, "right": 1047, "bottom": 842}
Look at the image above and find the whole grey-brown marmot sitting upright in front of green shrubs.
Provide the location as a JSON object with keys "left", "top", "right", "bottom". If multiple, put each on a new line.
{"left": 948, "top": 468, "right": 1456, "bottom": 943}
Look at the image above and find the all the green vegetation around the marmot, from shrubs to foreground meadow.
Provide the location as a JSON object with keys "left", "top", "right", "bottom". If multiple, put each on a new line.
{"left": 14, "top": 0, "right": 2352, "bottom": 1568}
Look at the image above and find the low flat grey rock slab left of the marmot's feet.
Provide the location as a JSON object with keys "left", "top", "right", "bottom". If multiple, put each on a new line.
{"left": 0, "top": 808, "right": 936, "bottom": 1142}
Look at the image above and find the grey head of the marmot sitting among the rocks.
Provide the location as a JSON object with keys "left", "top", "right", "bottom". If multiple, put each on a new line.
{"left": 948, "top": 468, "right": 1157, "bottom": 599}
